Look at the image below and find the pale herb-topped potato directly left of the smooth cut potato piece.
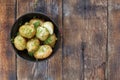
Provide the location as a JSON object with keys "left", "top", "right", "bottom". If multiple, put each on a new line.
{"left": 36, "top": 27, "right": 49, "bottom": 41}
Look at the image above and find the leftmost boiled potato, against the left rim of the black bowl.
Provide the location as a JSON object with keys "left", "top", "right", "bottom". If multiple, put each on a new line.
{"left": 14, "top": 35, "right": 26, "bottom": 50}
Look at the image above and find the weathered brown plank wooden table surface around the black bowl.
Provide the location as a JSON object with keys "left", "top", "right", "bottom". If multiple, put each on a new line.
{"left": 0, "top": 0, "right": 120, "bottom": 80}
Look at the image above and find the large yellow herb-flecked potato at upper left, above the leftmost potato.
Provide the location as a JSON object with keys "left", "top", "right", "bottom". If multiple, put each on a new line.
{"left": 19, "top": 24, "right": 36, "bottom": 39}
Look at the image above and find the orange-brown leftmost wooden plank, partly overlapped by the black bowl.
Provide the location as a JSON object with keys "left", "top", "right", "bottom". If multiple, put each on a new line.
{"left": 0, "top": 0, "right": 16, "bottom": 80}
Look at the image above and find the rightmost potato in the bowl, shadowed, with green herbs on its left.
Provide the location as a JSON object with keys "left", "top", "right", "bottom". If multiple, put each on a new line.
{"left": 44, "top": 34, "right": 57, "bottom": 47}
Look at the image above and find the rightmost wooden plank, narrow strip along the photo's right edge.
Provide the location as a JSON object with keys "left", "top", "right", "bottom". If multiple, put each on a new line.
{"left": 108, "top": 0, "right": 120, "bottom": 80}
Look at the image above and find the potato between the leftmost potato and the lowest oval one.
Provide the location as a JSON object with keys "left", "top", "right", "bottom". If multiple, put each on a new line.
{"left": 27, "top": 38, "right": 40, "bottom": 56}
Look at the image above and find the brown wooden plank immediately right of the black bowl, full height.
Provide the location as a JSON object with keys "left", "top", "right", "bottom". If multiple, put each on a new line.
{"left": 62, "top": 0, "right": 85, "bottom": 80}
